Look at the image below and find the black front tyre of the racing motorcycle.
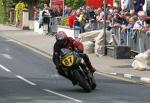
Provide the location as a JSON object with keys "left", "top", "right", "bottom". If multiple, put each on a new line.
{"left": 74, "top": 71, "right": 91, "bottom": 92}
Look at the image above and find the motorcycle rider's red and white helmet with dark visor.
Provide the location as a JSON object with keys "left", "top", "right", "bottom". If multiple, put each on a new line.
{"left": 56, "top": 31, "right": 67, "bottom": 46}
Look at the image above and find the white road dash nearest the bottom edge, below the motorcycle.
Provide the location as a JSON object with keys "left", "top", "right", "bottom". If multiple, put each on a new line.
{"left": 43, "top": 89, "right": 83, "bottom": 103}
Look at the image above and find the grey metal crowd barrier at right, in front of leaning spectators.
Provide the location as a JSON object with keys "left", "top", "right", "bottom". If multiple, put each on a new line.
{"left": 113, "top": 28, "right": 150, "bottom": 53}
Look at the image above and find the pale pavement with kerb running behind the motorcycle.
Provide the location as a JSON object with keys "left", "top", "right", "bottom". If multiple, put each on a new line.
{"left": 0, "top": 24, "right": 150, "bottom": 84}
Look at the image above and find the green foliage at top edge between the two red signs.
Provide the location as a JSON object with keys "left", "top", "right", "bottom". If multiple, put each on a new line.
{"left": 65, "top": 0, "right": 85, "bottom": 9}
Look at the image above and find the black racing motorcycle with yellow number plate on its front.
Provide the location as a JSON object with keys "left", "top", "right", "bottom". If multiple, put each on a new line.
{"left": 60, "top": 48, "right": 96, "bottom": 92}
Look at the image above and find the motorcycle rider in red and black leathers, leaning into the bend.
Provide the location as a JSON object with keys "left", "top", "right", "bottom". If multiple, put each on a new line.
{"left": 53, "top": 31, "right": 96, "bottom": 79}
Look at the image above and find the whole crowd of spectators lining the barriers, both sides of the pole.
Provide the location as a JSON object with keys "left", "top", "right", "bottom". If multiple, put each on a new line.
{"left": 34, "top": 0, "right": 150, "bottom": 39}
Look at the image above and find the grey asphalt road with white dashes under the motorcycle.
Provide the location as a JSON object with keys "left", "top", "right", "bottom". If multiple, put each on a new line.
{"left": 0, "top": 38, "right": 150, "bottom": 103}
